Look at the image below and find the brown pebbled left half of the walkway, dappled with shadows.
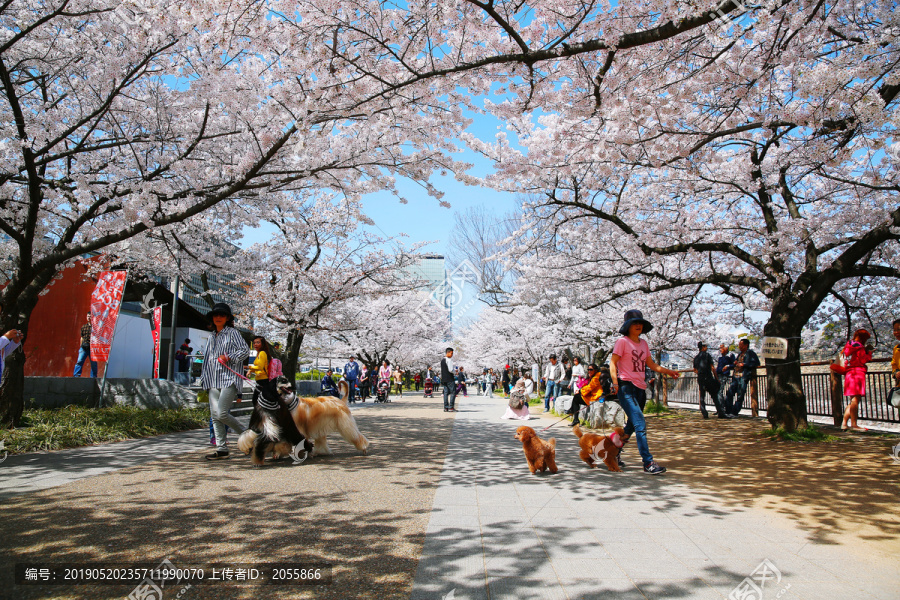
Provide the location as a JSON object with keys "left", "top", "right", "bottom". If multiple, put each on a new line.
{"left": 0, "top": 402, "right": 452, "bottom": 600}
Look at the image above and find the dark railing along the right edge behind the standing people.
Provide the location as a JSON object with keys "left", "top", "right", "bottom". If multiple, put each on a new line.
{"left": 666, "top": 360, "right": 900, "bottom": 424}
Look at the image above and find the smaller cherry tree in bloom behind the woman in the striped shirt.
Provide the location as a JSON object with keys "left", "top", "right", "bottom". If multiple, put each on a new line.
{"left": 244, "top": 196, "right": 428, "bottom": 378}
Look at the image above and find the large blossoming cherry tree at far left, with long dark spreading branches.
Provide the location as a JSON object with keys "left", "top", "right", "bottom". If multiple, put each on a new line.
{"left": 0, "top": 0, "right": 472, "bottom": 426}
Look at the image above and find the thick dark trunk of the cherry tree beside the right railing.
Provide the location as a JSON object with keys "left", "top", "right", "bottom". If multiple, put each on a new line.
{"left": 760, "top": 309, "right": 807, "bottom": 431}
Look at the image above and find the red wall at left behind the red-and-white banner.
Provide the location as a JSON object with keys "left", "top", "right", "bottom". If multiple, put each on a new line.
{"left": 24, "top": 263, "right": 103, "bottom": 377}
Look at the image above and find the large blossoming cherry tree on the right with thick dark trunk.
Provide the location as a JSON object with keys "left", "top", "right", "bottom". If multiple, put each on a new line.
{"left": 432, "top": 2, "right": 900, "bottom": 429}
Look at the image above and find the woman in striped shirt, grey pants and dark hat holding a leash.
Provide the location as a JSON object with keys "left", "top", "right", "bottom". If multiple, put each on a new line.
{"left": 200, "top": 302, "right": 250, "bottom": 460}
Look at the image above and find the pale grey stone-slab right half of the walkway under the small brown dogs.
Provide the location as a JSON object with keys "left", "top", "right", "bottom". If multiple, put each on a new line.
{"left": 412, "top": 396, "right": 900, "bottom": 600}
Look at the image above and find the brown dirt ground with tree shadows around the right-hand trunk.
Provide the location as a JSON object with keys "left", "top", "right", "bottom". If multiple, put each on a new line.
{"left": 647, "top": 410, "right": 900, "bottom": 556}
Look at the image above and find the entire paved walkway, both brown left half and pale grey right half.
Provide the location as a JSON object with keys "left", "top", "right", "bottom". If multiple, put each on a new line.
{"left": 0, "top": 393, "right": 900, "bottom": 600}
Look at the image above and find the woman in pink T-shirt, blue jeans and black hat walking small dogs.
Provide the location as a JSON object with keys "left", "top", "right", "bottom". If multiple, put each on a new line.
{"left": 609, "top": 310, "right": 679, "bottom": 475}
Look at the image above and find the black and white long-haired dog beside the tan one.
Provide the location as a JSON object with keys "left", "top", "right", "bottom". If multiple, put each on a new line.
{"left": 238, "top": 376, "right": 313, "bottom": 467}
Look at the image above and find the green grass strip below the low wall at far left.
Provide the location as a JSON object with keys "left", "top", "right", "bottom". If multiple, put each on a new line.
{"left": 0, "top": 405, "right": 209, "bottom": 454}
